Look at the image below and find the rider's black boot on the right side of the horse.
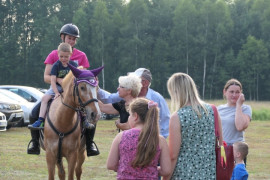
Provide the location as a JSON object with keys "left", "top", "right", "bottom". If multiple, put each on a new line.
{"left": 85, "top": 125, "right": 99, "bottom": 156}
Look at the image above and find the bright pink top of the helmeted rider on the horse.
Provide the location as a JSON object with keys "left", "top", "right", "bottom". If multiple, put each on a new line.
{"left": 44, "top": 48, "right": 90, "bottom": 68}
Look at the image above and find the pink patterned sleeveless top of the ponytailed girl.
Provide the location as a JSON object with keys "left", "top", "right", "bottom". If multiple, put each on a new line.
{"left": 117, "top": 128, "right": 161, "bottom": 180}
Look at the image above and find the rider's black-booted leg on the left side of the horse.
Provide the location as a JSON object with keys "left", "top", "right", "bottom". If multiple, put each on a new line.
{"left": 27, "top": 103, "right": 40, "bottom": 155}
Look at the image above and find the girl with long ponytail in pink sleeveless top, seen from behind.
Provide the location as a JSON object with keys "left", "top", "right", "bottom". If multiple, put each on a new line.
{"left": 107, "top": 98, "right": 171, "bottom": 180}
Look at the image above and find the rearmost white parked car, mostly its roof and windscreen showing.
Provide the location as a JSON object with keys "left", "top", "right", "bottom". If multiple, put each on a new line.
{"left": 0, "top": 85, "right": 44, "bottom": 103}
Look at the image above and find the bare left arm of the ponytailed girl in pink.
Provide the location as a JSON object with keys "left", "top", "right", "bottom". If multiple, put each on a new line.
{"left": 107, "top": 132, "right": 123, "bottom": 171}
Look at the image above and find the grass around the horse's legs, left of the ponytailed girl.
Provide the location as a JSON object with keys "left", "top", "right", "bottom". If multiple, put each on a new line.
{"left": 0, "top": 120, "right": 117, "bottom": 180}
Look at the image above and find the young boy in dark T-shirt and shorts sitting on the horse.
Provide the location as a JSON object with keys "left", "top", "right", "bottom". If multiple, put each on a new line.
{"left": 28, "top": 43, "right": 78, "bottom": 129}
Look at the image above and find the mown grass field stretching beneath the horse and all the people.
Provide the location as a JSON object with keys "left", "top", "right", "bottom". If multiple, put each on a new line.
{"left": 0, "top": 101, "right": 270, "bottom": 180}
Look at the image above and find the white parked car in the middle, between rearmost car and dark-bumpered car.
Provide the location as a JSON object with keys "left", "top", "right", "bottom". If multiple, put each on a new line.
{"left": 0, "top": 89, "right": 35, "bottom": 126}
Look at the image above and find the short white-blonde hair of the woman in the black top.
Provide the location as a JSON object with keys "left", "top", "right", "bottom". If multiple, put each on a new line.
{"left": 118, "top": 74, "right": 142, "bottom": 97}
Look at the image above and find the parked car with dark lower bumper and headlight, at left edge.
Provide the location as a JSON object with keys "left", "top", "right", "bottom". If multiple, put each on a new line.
{"left": 0, "top": 94, "right": 24, "bottom": 129}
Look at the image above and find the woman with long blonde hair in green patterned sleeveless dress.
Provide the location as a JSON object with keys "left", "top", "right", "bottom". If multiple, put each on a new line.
{"left": 165, "top": 73, "right": 223, "bottom": 180}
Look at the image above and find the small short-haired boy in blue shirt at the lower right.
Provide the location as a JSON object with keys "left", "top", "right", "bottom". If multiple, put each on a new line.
{"left": 231, "top": 142, "right": 248, "bottom": 180}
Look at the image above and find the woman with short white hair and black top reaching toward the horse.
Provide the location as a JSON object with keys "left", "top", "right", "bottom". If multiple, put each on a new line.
{"left": 98, "top": 74, "right": 142, "bottom": 130}
